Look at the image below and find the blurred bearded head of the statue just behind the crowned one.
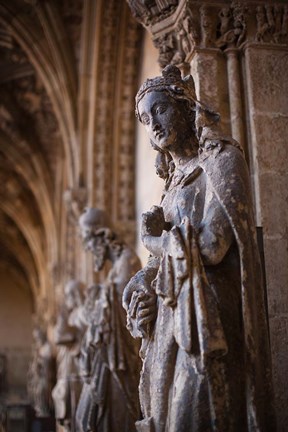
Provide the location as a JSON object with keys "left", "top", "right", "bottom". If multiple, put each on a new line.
{"left": 79, "top": 207, "right": 115, "bottom": 271}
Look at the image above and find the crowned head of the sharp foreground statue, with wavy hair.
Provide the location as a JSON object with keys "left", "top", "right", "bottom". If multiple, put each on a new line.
{"left": 136, "top": 65, "right": 219, "bottom": 162}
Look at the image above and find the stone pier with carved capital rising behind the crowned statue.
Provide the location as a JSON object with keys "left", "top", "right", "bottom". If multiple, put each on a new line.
{"left": 128, "top": 0, "right": 288, "bottom": 431}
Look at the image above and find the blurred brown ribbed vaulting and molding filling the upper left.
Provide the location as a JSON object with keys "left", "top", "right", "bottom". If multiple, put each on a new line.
{"left": 0, "top": 0, "right": 142, "bottom": 316}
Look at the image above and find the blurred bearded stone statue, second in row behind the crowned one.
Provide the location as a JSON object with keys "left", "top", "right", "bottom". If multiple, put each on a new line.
{"left": 77, "top": 208, "right": 140, "bottom": 432}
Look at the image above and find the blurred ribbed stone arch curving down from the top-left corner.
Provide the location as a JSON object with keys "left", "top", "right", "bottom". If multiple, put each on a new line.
{"left": 0, "top": 0, "right": 79, "bottom": 187}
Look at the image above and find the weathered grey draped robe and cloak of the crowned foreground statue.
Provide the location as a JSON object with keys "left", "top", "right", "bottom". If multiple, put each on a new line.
{"left": 128, "top": 144, "right": 275, "bottom": 432}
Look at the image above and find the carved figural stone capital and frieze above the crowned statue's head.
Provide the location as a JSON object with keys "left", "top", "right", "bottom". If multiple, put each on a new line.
{"left": 127, "top": 0, "right": 288, "bottom": 67}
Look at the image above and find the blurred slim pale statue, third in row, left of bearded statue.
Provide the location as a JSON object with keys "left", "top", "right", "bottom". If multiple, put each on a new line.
{"left": 52, "top": 279, "right": 86, "bottom": 432}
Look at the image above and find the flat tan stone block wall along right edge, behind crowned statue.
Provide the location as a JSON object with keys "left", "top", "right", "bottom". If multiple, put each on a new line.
{"left": 245, "top": 44, "right": 288, "bottom": 432}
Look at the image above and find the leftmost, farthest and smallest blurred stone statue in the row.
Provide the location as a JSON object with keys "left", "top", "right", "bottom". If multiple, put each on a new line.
{"left": 27, "top": 327, "right": 55, "bottom": 417}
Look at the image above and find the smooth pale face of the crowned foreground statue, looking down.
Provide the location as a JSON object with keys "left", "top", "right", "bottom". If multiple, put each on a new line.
{"left": 138, "top": 91, "right": 191, "bottom": 150}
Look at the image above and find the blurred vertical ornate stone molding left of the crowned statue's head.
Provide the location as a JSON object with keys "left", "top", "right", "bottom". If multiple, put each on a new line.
{"left": 80, "top": 0, "right": 142, "bottom": 243}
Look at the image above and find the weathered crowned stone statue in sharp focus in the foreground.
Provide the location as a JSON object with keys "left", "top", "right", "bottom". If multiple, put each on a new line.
{"left": 123, "top": 66, "right": 276, "bottom": 432}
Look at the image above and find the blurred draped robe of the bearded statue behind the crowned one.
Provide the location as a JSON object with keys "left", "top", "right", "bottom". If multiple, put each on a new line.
{"left": 76, "top": 246, "right": 140, "bottom": 432}
